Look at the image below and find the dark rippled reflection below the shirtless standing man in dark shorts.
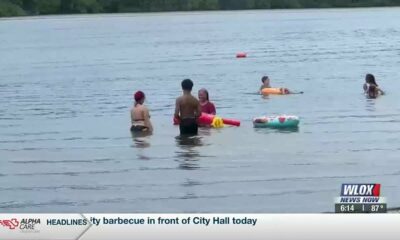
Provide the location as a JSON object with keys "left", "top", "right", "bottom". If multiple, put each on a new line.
{"left": 175, "top": 135, "right": 203, "bottom": 170}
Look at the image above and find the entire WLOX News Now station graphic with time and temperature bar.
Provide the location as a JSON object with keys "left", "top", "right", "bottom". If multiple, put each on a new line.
{"left": 335, "top": 183, "right": 387, "bottom": 213}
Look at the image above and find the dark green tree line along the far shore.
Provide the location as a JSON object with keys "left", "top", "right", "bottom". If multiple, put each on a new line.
{"left": 0, "top": 0, "right": 400, "bottom": 17}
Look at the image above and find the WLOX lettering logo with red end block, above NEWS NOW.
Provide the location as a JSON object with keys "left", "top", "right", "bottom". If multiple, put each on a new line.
{"left": 340, "top": 183, "right": 381, "bottom": 197}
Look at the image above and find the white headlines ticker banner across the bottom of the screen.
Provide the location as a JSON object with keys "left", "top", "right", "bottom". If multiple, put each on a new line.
{"left": 0, "top": 214, "right": 400, "bottom": 240}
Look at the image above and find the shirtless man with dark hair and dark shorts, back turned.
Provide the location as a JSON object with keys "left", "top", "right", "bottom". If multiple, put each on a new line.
{"left": 174, "top": 79, "right": 201, "bottom": 135}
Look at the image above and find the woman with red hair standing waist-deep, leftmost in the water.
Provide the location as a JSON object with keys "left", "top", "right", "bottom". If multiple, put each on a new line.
{"left": 131, "top": 91, "right": 153, "bottom": 132}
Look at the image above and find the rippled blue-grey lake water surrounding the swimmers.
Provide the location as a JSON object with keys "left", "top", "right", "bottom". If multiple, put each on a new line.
{"left": 0, "top": 8, "right": 400, "bottom": 213}
